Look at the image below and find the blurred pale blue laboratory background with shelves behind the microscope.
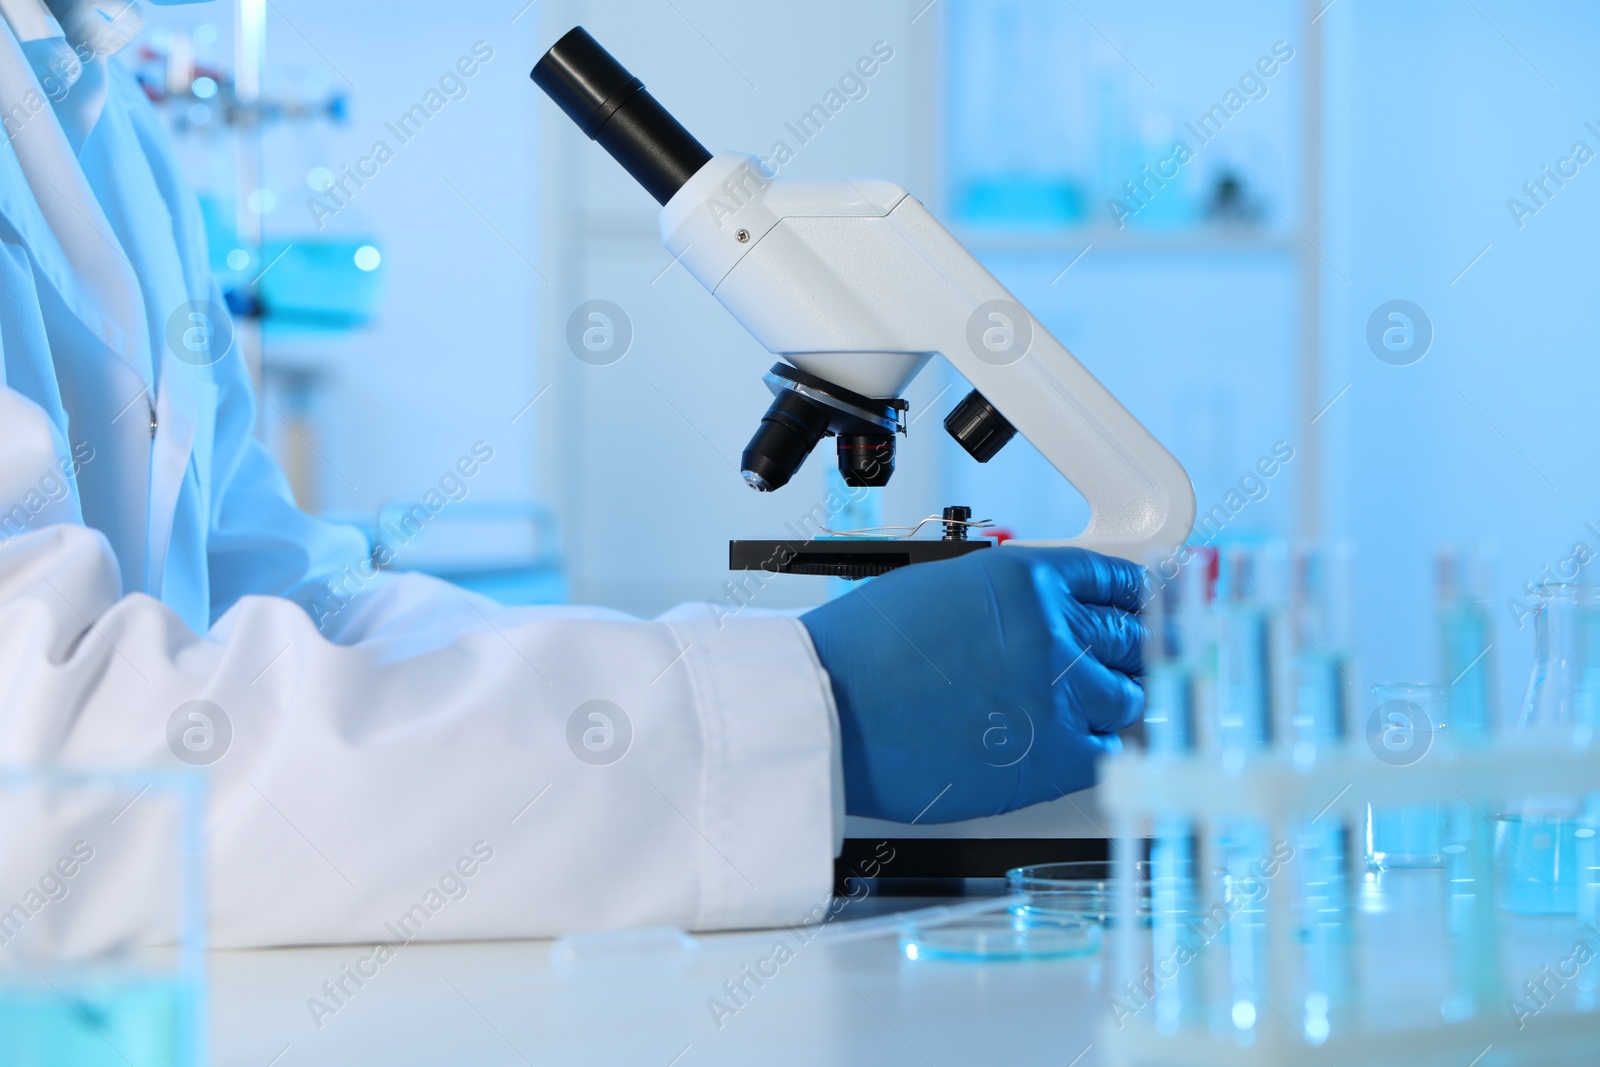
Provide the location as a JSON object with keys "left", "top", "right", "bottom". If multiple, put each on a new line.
{"left": 134, "top": 0, "right": 1600, "bottom": 726}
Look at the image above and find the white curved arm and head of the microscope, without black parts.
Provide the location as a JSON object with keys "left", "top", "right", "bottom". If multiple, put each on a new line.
{"left": 661, "top": 154, "right": 1195, "bottom": 560}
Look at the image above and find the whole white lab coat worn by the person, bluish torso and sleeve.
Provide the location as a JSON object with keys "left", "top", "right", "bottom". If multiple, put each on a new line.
{"left": 0, "top": 10, "right": 842, "bottom": 945}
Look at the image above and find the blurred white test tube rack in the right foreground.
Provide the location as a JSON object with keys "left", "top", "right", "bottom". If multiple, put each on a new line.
{"left": 1099, "top": 734, "right": 1600, "bottom": 1067}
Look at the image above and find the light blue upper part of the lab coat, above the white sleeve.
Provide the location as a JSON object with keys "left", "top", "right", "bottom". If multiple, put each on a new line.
{"left": 0, "top": 31, "right": 370, "bottom": 632}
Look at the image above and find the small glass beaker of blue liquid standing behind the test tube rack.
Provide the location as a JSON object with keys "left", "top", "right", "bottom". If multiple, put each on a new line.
{"left": 1366, "top": 681, "right": 1448, "bottom": 869}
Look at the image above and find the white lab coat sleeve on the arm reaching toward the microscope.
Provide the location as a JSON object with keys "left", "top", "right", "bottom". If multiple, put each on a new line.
{"left": 0, "top": 389, "right": 835, "bottom": 947}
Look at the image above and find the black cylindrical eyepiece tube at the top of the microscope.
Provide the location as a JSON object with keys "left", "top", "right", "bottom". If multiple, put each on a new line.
{"left": 528, "top": 26, "right": 710, "bottom": 203}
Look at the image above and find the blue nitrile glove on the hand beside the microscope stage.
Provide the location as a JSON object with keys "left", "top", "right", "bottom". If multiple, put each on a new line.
{"left": 800, "top": 545, "right": 1144, "bottom": 822}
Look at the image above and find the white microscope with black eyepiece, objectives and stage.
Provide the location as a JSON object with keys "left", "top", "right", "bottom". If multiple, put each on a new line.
{"left": 531, "top": 27, "right": 1195, "bottom": 877}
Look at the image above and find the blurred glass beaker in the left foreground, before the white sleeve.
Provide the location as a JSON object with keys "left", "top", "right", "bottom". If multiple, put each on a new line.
{"left": 0, "top": 768, "right": 205, "bottom": 1067}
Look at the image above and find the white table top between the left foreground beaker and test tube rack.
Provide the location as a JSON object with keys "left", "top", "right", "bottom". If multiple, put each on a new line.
{"left": 210, "top": 901, "right": 1106, "bottom": 1067}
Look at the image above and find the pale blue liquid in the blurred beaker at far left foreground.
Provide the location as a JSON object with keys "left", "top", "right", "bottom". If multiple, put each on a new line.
{"left": 0, "top": 976, "right": 200, "bottom": 1067}
